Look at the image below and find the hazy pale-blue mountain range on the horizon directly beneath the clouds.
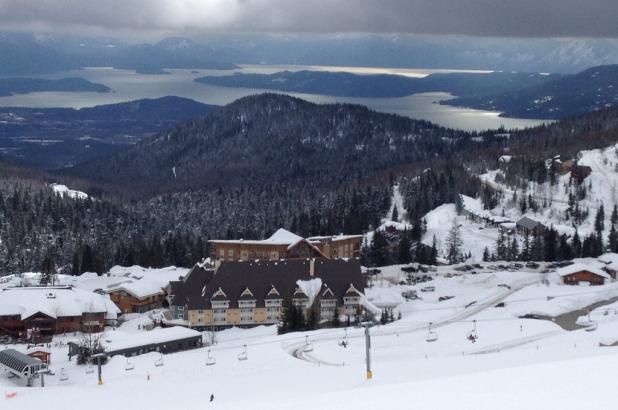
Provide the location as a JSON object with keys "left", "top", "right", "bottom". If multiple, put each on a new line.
{"left": 0, "top": 33, "right": 618, "bottom": 76}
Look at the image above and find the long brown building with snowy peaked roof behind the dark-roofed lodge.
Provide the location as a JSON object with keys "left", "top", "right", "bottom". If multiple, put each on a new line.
{"left": 210, "top": 228, "right": 363, "bottom": 262}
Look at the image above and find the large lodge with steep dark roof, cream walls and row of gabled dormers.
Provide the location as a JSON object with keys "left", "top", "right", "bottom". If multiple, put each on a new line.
{"left": 170, "top": 258, "right": 365, "bottom": 330}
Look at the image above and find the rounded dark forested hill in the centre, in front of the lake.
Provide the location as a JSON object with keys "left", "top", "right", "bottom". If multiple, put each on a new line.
{"left": 63, "top": 94, "right": 479, "bottom": 194}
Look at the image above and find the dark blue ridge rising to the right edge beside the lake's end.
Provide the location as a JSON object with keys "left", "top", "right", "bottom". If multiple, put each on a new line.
{"left": 446, "top": 65, "right": 618, "bottom": 119}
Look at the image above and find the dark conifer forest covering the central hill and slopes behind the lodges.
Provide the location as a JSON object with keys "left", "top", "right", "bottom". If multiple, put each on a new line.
{"left": 0, "top": 94, "right": 618, "bottom": 273}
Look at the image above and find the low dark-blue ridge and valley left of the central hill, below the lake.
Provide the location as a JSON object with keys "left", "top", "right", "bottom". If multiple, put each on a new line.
{"left": 0, "top": 97, "right": 218, "bottom": 169}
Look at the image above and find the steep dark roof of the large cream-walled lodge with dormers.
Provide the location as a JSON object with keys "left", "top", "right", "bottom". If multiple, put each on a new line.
{"left": 185, "top": 259, "right": 364, "bottom": 310}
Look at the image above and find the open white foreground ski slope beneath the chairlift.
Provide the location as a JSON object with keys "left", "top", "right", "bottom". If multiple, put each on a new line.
{"left": 6, "top": 257, "right": 618, "bottom": 410}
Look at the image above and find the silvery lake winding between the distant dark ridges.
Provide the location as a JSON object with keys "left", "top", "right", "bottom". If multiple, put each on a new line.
{"left": 0, "top": 65, "right": 545, "bottom": 131}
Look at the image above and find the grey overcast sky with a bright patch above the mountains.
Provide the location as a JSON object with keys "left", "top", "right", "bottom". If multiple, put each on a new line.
{"left": 0, "top": 0, "right": 618, "bottom": 38}
